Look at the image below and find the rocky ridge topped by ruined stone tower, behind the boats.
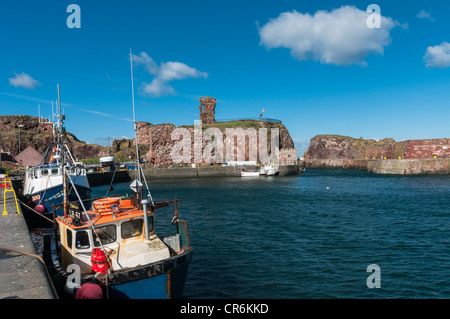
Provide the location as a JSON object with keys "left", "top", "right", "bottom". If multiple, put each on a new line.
{"left": 0, "top": 114, "right": 294, "bottom": 166}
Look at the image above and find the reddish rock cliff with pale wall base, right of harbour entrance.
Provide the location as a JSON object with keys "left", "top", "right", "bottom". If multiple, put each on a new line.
{"left": 303, "top": 135, "right": 450, "bottom": 175}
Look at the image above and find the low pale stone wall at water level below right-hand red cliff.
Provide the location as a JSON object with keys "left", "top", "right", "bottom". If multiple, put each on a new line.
{"left": 305, "top": 158, "right": 450, "bottom": 175}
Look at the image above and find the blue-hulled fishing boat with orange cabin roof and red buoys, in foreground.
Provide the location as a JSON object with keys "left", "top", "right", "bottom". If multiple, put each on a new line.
{"left": 44, "top": 50, "right": 193, "bottom": 299}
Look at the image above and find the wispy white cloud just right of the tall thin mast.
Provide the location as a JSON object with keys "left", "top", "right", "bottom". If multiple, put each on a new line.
{"left": 133, "top": 52, "right": 208, "bottom": 97}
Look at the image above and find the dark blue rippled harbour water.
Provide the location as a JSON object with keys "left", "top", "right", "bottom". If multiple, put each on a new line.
{"left": 88, "top": 169, "right": 450, "bottom": 299}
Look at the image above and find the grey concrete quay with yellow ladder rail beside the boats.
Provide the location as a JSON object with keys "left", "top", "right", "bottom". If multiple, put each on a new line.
{"left": 0, "top": 179, "right": 57, "bottom": 299}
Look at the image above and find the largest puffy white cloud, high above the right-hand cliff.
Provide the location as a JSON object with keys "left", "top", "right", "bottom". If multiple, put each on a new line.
{"left": 259, "top": 6, "right": 407, "bottom": 66}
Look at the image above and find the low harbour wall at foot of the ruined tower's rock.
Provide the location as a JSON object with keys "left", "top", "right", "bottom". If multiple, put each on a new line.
{"left": 87, "top": 165, "right": 300, "bottom": 187}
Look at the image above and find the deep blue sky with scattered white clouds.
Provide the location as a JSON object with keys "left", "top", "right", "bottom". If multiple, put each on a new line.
{"left": 0, "top": 0, "right": 450, "bottom": 153}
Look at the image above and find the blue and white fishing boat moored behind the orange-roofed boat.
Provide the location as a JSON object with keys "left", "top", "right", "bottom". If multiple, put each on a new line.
{"left": 23, "top": 86, "right": 91, "bottom": 215}
